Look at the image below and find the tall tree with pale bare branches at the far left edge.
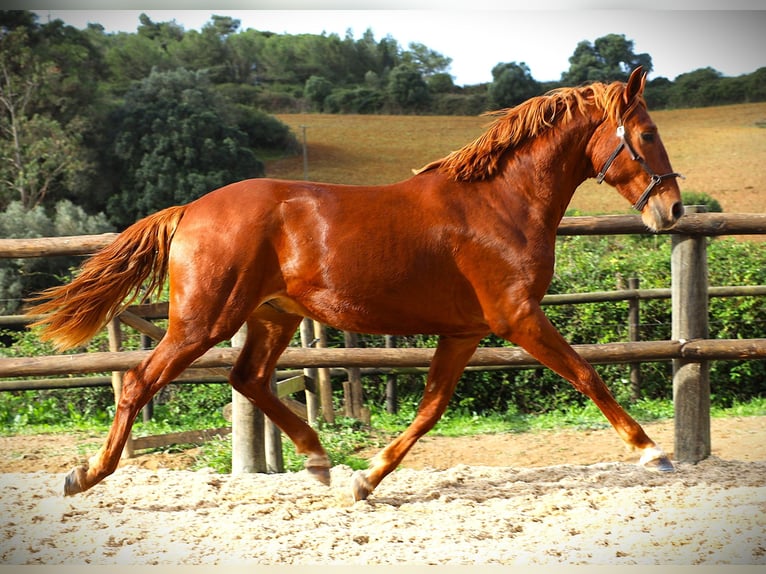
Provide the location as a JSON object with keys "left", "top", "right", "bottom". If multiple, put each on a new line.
{"left": 0, "top": 20, "right": 103, "bottom": 214}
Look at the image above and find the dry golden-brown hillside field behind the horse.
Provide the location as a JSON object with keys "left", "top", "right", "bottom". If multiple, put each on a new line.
{"left": 266, "top": 103, "right": 766, "bottom": 214}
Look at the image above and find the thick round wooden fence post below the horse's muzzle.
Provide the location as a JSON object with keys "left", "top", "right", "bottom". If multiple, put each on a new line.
{"left": 670, "top": 206, "right": 711, "bottom": 463}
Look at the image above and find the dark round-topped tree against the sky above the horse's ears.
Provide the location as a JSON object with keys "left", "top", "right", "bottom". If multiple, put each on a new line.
{"left": 561, "top": 34, "right": 652, "bottom": 85}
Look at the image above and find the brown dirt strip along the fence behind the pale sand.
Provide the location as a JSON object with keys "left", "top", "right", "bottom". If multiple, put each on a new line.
{"left": 0, "top": 417, "right": 766, "bottom": 472}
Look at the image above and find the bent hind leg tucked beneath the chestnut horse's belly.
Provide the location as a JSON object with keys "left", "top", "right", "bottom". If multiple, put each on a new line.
{"left": 229, "top": 305, "right": 331, "bottom": 485}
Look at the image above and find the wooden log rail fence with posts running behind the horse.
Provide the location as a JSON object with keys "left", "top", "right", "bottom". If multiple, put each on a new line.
{"left": 0, "top": 212, "right": 766, "bottom": 471}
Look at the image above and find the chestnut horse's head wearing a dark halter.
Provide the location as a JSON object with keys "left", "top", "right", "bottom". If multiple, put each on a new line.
{"left": 589, "top": 67, "right": 684, "bottom": 231}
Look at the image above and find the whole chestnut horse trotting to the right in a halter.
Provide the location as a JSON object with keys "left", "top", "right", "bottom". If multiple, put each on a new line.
{"left": 27, "top": 68, "right": 684, "bottom": 500}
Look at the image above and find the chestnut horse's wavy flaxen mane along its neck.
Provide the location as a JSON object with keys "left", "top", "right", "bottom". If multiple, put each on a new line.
{"left": 416, "top": 82, "right": 643, "bottom": 181}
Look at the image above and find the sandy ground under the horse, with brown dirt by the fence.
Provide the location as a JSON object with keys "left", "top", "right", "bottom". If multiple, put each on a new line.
{"left": 0, "top": 417, "right": 766, "bottom": 565}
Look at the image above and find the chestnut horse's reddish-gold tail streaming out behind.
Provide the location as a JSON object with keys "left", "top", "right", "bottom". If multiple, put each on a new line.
{"left": 26, "top": 206, "right": 186, "bottom": 350}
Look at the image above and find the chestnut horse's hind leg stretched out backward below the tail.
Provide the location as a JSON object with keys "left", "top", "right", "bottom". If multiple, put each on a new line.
{"left": 64, "top": 326, "right": 217, "bottom": 495}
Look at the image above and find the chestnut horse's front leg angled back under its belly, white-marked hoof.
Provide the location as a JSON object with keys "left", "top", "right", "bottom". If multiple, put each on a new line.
{"left": 353, "top": 336, "right": 481, "bottom": 500}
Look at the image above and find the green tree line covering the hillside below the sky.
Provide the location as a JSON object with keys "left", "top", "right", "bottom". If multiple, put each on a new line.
{"left": 0, "top": 10, "right": 766, "bottom": 309}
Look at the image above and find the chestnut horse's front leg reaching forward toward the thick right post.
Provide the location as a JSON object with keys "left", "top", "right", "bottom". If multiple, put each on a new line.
{"left": 491, "top": 301, "right": 673, "bottom": 471}
